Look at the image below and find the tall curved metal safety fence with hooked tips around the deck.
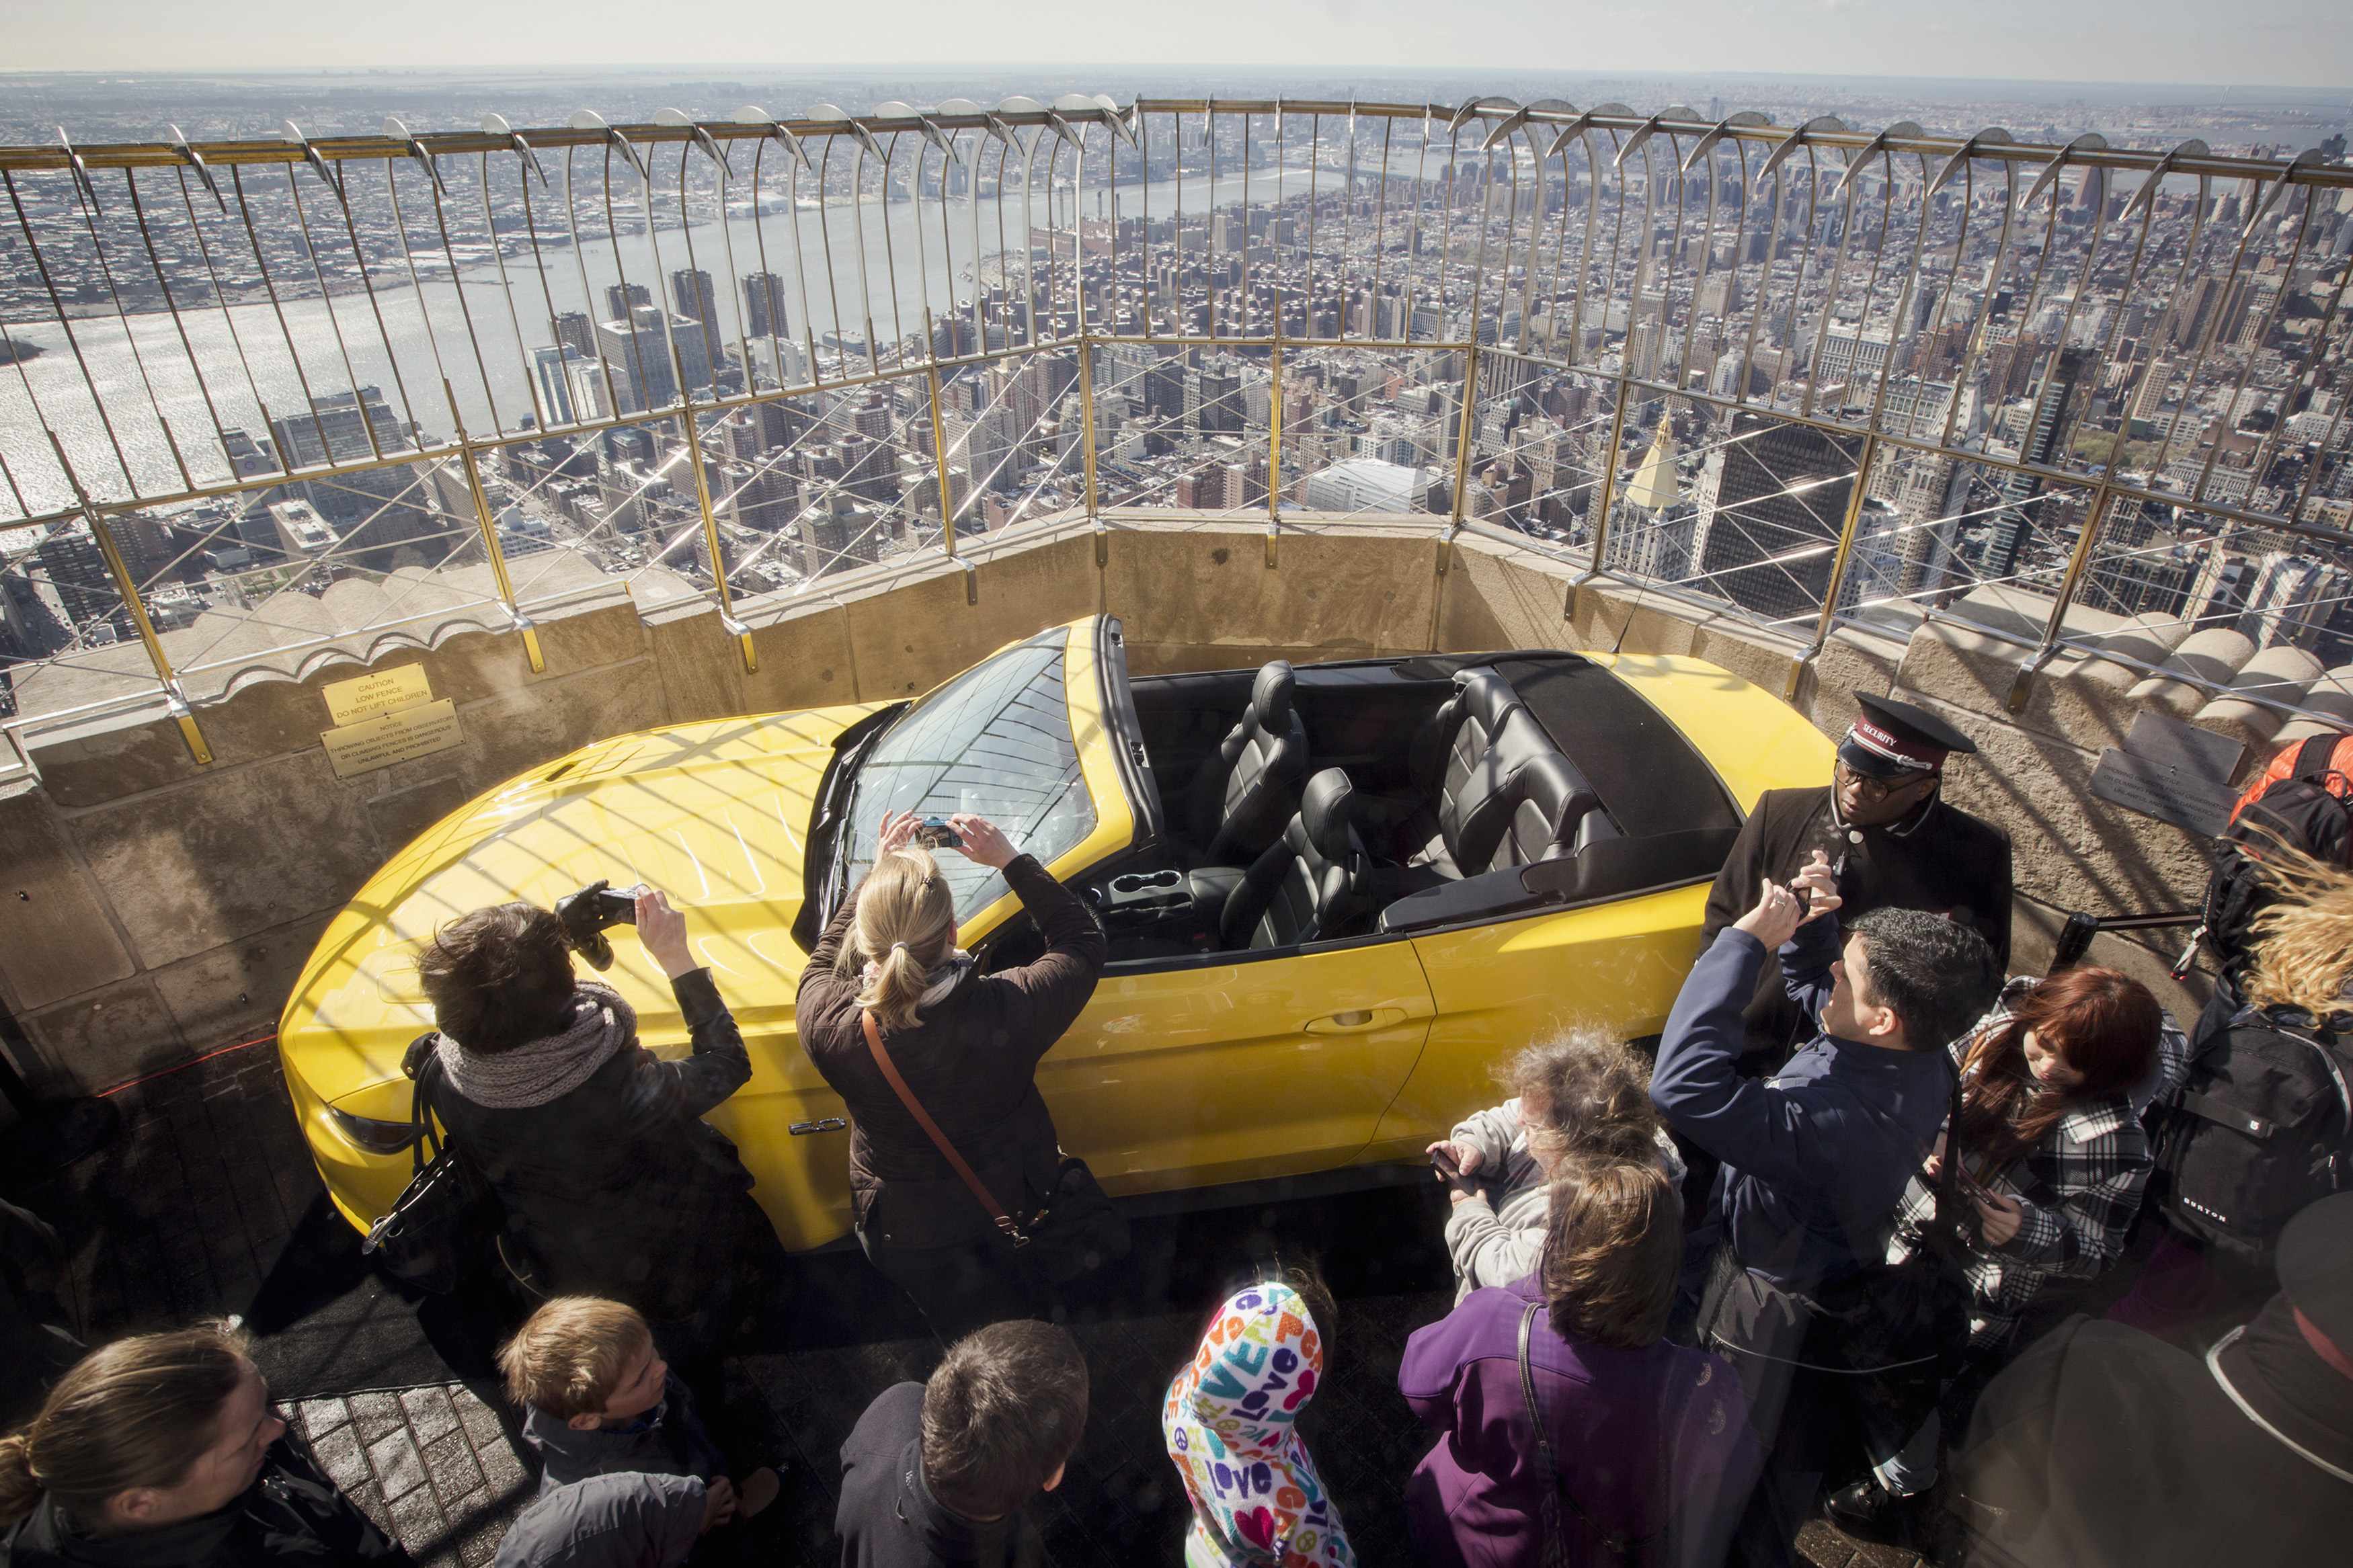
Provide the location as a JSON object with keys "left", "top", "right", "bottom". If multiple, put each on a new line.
{"left": 0, "top": 94, "right": 2353, "bottom": 759}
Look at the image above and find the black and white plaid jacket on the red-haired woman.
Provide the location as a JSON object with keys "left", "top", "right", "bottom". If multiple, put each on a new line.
{"left": 1887, "top": 976, "right": 2191, "bottom": 1350}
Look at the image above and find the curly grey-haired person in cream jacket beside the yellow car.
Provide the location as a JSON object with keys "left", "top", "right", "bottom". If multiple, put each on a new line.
{"left": 1429, "top": 1030, "right": 1683, "bottom": 1305}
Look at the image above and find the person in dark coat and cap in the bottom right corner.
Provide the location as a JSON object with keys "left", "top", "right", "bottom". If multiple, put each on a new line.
{"left": 1953, "top": 1192, "right": 2353, "bottom": 1568}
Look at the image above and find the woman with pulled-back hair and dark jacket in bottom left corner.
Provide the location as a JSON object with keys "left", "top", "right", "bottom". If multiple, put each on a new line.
{"left": 0, "top": 1323, "right": 409, "bottom": 1568}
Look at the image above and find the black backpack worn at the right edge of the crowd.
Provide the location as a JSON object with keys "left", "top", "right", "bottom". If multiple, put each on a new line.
{"left": 2153, "top": 1006, "right": 2353, "bottom": 1267}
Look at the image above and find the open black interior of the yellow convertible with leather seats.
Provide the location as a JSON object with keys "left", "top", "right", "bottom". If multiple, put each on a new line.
{"left": 1049, "top": 651, "right": 1741, "bottom": 962}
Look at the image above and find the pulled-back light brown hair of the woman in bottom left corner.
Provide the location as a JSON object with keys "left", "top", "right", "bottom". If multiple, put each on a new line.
{"left": 0, "top": 1321, "right": 252, "bottom": 1526}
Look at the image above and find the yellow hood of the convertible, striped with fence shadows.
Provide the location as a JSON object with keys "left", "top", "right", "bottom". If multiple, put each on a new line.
{"left": 280, "top": 705, "right": 875, "bottom": 1114}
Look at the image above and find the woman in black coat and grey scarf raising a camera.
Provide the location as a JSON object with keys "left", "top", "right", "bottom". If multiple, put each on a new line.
{"left": 409, "top": 891, "right": 774, "bottom": 1383}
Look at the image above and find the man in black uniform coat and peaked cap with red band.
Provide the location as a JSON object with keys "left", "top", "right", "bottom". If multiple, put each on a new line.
{"left": 1699, "top": 694, "right": 2009, "bottom": 1055}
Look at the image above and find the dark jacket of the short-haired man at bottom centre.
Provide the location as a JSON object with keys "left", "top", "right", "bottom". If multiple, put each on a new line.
{"left": 833, "top": 1383, "right": 1045, "bottom": 1568}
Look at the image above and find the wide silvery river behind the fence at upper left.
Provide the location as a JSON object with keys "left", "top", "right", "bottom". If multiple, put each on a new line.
{"left": 0, "top": 169, "right": 1339, "bottom": 522}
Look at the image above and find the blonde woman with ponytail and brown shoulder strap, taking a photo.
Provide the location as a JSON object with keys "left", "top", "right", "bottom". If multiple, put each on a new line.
{"left": 798, "top": 811, "right": 1104, "bottom": 1340}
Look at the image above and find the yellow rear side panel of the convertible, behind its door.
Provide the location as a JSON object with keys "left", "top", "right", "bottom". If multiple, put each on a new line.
{"left": 1363, "top": 882, "right": 1708, "bottom": 1159}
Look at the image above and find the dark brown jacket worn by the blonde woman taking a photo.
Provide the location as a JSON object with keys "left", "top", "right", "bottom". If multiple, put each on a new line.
{"left": 795, "top": 856, "right": 1106, "bottom": 1246}
